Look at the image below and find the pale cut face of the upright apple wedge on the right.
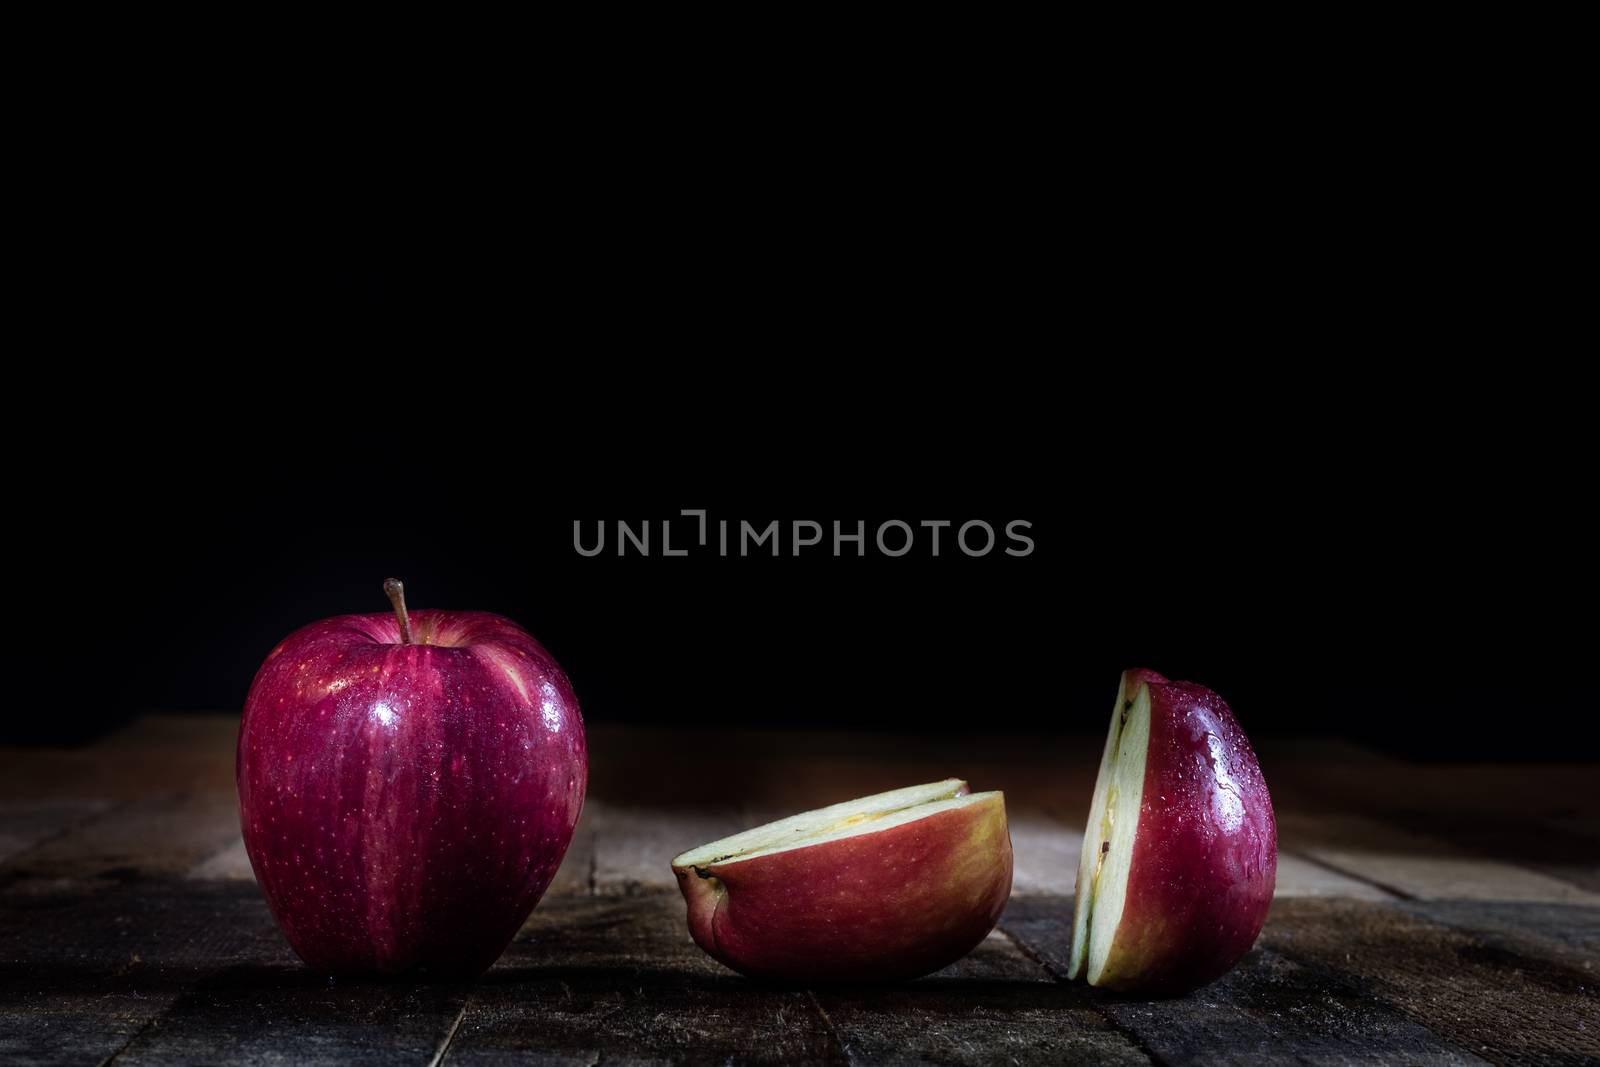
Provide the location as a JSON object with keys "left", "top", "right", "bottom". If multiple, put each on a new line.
{"left": 1067, "top": 675, "right": 1150, "bottom": 985}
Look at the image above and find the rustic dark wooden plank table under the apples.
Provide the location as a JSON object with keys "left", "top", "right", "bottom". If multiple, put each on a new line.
{"left": 0, "top": 717, "right": 1600, "bottom": 1067}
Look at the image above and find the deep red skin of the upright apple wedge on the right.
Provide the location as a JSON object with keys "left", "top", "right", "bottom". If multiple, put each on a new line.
{"left": 1099, "top": 669, "right": 1278, "bottom": 995}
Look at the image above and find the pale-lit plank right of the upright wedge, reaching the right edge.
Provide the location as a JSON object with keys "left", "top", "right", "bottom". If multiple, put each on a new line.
{"left": 1278, "top": 813, "right": 1600, "bottom": 904}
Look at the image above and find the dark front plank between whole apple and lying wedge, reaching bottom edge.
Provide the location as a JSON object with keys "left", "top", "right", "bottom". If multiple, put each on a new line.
{"left": 445, "top": 894, "right": 848, "bottom": 1067}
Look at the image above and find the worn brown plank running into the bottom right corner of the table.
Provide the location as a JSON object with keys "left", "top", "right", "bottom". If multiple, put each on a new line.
{"left": 1261, "top": 901, "right": 1600, "bottom": 1064}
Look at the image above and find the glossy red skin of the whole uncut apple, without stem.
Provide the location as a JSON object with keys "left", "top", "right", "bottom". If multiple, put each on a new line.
{"left": 237, "top": 611, "right": 589, "bottom": 977}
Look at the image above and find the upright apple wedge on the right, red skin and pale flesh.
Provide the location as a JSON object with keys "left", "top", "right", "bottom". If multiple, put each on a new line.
{"left": 1067, "top": 670, "right": 1278, "bottom": 993}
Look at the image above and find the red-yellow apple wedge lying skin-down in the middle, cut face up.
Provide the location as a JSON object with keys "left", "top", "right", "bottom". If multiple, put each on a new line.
{"left": 672, "top": 777, "right": 1011, "bottom": 982}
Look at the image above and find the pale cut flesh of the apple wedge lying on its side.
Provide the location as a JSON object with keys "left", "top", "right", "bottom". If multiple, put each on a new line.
{"left": 672, "top": 777, "right": 995, "bottom": 870}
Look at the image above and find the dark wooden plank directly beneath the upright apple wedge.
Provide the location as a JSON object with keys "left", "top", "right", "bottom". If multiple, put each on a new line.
{"left": 1000, "top": 897, "right": 1482, "bottom": 1064}
